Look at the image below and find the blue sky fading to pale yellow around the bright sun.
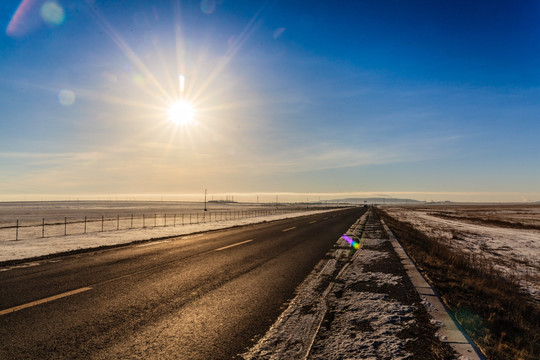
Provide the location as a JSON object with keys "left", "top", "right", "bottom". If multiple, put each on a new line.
{"left": 0, "top": 0, "right": 540, "bottom": 201}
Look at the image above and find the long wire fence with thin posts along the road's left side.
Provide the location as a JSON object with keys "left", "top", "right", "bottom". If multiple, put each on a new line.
{"left": 0, "top": 209, "right": 298, "bottom": 241}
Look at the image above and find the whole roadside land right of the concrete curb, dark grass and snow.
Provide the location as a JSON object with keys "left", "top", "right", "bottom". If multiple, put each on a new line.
{"left": 379, "top": 205, "right": 540, "bottom": 360}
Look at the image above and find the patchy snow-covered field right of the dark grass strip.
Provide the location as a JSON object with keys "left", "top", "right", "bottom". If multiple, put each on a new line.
{"left": 384, "top": 205, "right": 540, "bottom": 301}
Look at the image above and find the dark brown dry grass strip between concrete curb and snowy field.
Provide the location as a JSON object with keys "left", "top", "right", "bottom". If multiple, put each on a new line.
{"left": 377, "top": 209, "right": 540, "bottom": 360}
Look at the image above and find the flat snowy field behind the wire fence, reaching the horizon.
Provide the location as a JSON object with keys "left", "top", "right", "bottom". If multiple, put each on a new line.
{"left": 0, "top": 201, "right": 338, "bottom": 241}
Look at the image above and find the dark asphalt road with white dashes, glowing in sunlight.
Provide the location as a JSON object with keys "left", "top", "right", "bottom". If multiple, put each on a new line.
{"left": 0, "top": 208, "right": 364, "bottom": 359}
